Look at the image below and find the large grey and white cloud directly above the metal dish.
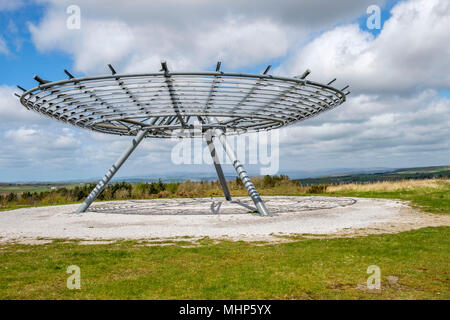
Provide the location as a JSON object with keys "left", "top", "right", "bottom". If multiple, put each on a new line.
{"left": 29, "top": 0, "right": 384, "bottom": 72}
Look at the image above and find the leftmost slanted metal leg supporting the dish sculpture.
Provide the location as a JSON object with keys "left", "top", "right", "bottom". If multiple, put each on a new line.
{"left": 77, "top": 129, "right": 148, "bottom": 213}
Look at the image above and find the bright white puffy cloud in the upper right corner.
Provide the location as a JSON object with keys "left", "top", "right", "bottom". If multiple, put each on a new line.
{"left": 278, "top": 0, "right": 450, "bottom": 94}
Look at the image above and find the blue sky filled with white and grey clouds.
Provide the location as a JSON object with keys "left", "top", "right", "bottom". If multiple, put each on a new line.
{"left": 0, "top": 0, "right": 450, "bottom": 182}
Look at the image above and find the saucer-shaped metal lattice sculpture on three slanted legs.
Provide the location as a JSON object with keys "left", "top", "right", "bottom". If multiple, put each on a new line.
{"left": 19, "top": 62, "right": 349, "bottom": 215}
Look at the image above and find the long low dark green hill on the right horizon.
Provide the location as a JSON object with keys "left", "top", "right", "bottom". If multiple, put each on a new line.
{"left": 296, "top": 166, "right": 450, "bottom": 185}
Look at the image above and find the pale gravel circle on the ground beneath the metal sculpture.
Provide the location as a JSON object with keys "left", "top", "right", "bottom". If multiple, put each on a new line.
{"left": 0, "top": 196, "right": 414, "bottom": 241}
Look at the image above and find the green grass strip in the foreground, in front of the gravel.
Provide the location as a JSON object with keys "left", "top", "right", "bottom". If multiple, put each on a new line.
{"left": 0, "top": 227, "right": 450, "bottom": 299}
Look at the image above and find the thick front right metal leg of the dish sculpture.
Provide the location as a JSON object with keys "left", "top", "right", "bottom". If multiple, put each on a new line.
{"left": 207, "top": 117, "right": 274, "bottom": 216}
